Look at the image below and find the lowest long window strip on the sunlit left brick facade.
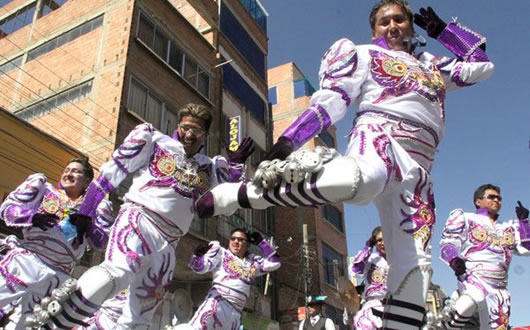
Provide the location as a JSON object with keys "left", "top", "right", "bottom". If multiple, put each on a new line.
{"left": 16, "top": 80, "right": 92, "bottom": 120}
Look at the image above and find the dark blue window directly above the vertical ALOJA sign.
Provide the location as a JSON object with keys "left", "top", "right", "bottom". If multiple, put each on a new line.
{"left": 223, "top": 64, "right": 266, "bottom": 125}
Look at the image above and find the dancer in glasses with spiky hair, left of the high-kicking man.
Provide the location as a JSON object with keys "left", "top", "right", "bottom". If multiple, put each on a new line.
{"left": 32, "top": 104, "right": 254, "bottom": 329}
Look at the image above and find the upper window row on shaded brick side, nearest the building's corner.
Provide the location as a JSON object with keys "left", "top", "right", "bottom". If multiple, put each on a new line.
{"left": 136, "top": 12, "right": 211, "bottom": 99}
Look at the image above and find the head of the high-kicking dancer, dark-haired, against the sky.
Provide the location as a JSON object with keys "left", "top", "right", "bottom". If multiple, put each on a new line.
{"left": 372, "top": 3, "right": 414, "bottom": 51}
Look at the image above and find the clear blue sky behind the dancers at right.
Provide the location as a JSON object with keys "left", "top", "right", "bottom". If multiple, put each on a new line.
{"left": 262, "top": 0, "right": 530, "bottom": 326}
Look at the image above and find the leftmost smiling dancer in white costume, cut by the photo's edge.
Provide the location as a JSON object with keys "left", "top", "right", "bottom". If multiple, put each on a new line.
{"left": 0, "top": 158, "right": 114, "bottom": 329}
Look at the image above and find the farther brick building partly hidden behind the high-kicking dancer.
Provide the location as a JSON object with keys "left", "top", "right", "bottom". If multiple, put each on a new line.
{"left": 268, "top": 63, "right": 348, "bottom": 329}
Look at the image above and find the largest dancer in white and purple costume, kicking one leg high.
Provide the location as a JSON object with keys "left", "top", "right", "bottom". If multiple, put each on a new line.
{"left": 196, "top": 0, "right": 493, "bottom": 329}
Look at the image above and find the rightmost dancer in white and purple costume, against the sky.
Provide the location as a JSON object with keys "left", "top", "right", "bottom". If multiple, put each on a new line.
{"left": 432, "top": 184, "right": 530, "bottom": 329}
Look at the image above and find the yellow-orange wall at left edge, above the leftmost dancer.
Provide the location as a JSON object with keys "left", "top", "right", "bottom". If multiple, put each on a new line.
{"left": 0, "top": 108, "right": 82, "bottom": 201}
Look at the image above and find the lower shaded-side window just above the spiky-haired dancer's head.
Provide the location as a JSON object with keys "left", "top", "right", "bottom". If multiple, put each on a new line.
{"left": 127, "top": 77, "right": 177, "bottom": 135}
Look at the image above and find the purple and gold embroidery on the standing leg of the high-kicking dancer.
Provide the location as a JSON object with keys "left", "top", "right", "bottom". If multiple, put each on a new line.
{"left": 399, "top": 168, "right": 436, "bottom": 250}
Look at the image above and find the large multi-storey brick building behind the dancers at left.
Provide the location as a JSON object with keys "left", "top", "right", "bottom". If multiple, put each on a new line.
{"left": 0, "top": 0, "right": 275, "bottom": 324}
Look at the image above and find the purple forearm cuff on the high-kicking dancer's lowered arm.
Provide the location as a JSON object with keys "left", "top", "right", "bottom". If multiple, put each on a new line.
{"left": 282, "top": 104, "right": 331, "bottom": 150}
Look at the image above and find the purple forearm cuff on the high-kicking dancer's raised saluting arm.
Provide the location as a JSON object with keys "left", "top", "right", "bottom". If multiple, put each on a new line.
{"left": 437, "top": 22, "right": 489, "bottom": 62}
